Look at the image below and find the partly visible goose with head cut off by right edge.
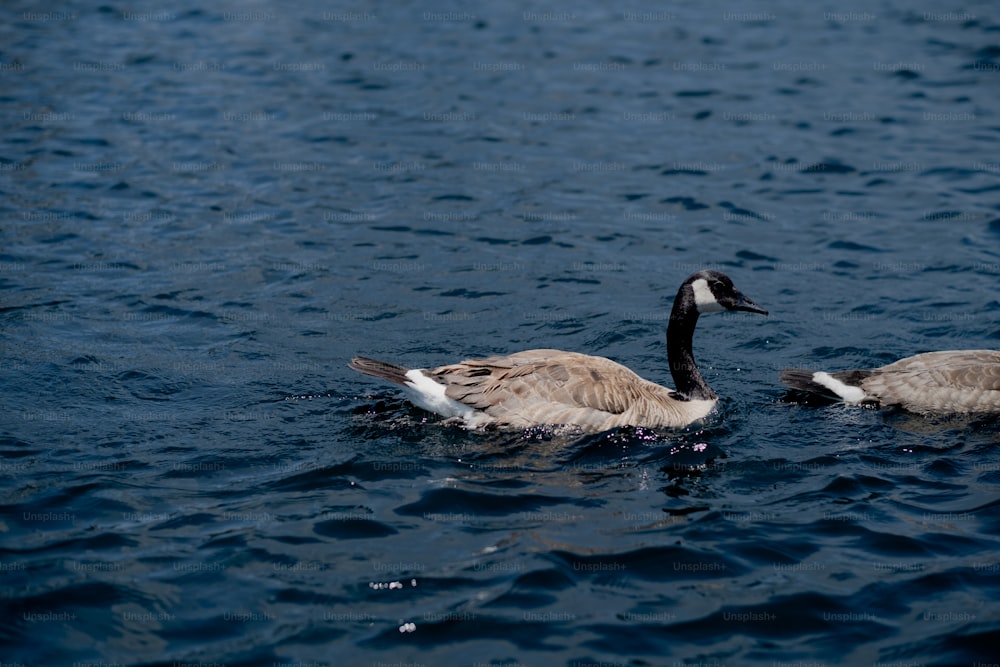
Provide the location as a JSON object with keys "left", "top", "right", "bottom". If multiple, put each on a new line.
{"left": 781, "top": 350, "right": 1000, "bottom": 414}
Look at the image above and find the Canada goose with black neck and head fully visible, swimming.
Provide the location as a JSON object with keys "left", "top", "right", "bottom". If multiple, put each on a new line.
{"left": 349, "top": 271, "right": 767, "bottom": 431}
